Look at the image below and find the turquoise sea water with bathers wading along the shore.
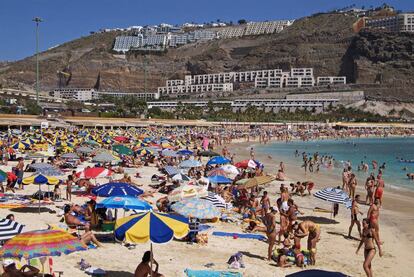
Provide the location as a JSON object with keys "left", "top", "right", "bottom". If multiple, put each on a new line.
{"left": 256, "top": 137, "right": 414, "bottom": 190}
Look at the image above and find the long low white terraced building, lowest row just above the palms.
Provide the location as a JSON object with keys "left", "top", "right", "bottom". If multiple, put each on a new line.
{"left": 147, "top": 98, "right": 339, "bottom": 112}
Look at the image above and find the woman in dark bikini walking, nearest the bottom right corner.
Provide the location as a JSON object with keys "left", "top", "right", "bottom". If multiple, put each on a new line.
{"left": 356, "top": 218, "right": 382, "bottom": 277}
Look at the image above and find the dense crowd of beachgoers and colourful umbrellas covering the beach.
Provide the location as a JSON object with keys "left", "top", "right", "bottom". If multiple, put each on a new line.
{"left": 0, "top": 126, "right": 414, "bottom": 276}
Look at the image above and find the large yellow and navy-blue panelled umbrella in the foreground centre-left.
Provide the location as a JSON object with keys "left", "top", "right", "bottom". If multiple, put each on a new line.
{"left": 114, "top": 211, "right": 190, "bottom": 243}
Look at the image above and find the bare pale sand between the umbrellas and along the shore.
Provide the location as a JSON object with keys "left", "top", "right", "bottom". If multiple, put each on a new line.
{"left": 0, "top": 137, "right": 414, "bottom": 276}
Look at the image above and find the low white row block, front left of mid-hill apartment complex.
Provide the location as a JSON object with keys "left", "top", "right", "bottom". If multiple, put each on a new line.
{"left": 158, "top": 83, "right": 233, "bottom": 95}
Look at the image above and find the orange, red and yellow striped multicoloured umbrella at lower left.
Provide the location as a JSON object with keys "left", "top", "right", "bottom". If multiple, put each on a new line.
{"left": 0, "top": 227, "right": 87, "bottom": 260}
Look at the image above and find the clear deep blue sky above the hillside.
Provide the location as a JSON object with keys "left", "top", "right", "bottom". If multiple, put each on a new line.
{"left": 0, "top": 0, "right": 414, "bottom": 61}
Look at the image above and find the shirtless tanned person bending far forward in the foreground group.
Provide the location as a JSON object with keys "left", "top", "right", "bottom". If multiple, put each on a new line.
{"left": 293, "top": 220, "right": 321, "bottom": 265}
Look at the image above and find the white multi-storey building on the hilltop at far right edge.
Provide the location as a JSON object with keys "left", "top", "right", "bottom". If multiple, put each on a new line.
{"left": 365, "top": 13, "right": 414, "bottom": 32}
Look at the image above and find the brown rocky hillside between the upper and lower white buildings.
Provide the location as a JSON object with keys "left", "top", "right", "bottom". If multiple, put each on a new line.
{"left": 0, "top": 14, "right": 414, "bottom": 100}
